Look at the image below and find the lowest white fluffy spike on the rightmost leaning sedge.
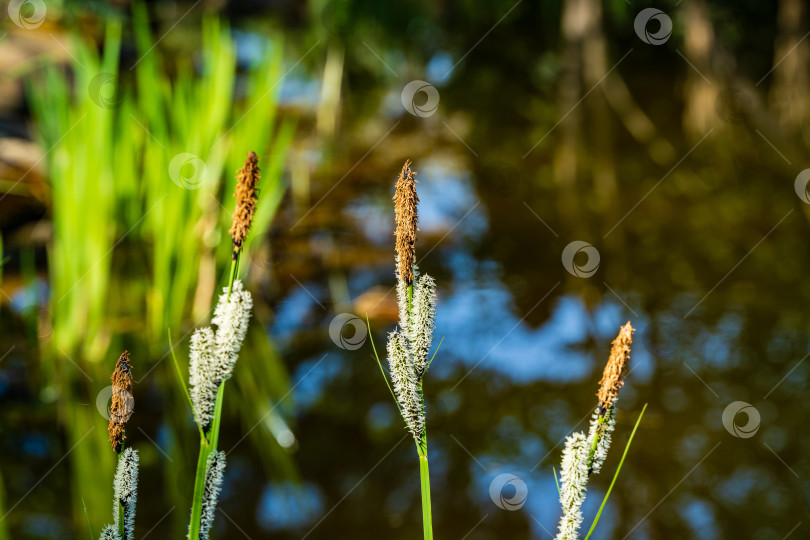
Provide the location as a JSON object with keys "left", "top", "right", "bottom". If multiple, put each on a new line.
{"left": 556, "top": 432, "right": 588, "bottom": 540}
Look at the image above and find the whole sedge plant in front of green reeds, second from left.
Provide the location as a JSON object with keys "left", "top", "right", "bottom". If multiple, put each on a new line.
{"left": 170, "top": 152, "right": 260, "bottom": 540}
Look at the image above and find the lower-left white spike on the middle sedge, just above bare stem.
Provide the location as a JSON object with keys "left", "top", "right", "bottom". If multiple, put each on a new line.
{"left": 388, "top": 332, "right": 425, "bottom": 442}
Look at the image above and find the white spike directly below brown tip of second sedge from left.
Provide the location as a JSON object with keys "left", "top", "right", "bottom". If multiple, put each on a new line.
{"left": 211, "top": 279, "right": 253, "bottom": 376}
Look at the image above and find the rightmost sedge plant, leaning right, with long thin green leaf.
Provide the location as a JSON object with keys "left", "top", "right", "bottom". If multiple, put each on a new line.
{"left": 555, "top": 322, "right": 646, "bottom": 540}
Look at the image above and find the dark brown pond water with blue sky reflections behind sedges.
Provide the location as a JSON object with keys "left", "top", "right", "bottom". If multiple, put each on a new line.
{"left": 0, "top": 0, "right": 810, "bottom": 540}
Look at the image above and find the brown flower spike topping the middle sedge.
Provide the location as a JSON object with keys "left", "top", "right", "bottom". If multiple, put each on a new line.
{"left": 394, "top": 160, "right": 419, "bottom": 286}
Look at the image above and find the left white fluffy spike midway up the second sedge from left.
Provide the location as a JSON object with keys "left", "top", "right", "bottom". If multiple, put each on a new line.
{"left": 188, "top": 327, "right": 220, "bottom": 431}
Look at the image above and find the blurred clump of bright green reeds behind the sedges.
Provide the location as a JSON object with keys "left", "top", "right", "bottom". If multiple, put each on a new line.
{"left": 27, "top": 4, "right": 295, "bottom": 523}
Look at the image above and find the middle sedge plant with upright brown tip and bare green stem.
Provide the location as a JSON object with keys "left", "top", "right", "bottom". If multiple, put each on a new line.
{"left": 372, "top": 161, "right": 438, "bottom": 539}
